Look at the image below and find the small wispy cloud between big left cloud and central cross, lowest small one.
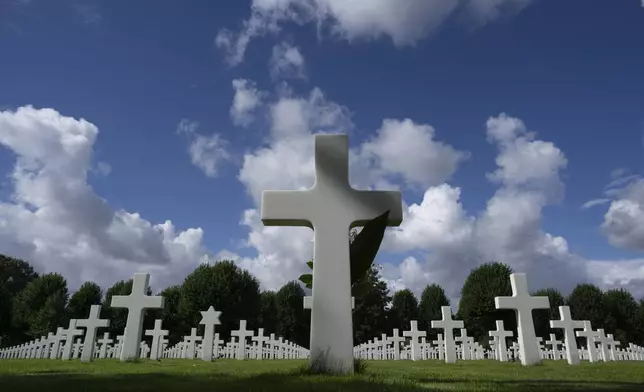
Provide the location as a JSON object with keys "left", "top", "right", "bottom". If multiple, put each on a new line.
{"left": 177, "top": 119, "right": 231, "bottom": 178}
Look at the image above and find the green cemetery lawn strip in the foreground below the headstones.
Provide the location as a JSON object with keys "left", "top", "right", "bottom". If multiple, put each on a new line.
{"left": 0, "top": 359, "right": 644, "bottom": 392}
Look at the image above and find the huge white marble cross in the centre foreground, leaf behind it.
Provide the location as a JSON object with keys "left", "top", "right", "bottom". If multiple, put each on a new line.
{"left": 262, "top": 135, "right": 402, "bottom": 373}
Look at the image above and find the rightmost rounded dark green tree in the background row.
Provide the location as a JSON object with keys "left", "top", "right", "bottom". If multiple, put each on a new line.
{"left": 603, "top": 289, "right": 638, "bottom": 343}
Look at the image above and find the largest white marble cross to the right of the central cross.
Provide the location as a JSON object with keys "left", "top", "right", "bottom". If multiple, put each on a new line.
{"left": 494, "top": 274, "right": 550, "bottom": 366}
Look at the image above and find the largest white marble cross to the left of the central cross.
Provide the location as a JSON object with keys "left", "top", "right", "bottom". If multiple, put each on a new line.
{"left": 110, "top": 273, "right": 165, "bottom": 361}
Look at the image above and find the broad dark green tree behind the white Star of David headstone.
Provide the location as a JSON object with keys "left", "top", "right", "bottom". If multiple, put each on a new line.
{"left": 179, "top": 260, "right": 260, "bottom": 339}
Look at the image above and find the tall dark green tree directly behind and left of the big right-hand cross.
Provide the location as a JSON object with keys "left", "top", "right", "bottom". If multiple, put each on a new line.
{"left": 458, "top": 263, "right": 517, "bottom": 343}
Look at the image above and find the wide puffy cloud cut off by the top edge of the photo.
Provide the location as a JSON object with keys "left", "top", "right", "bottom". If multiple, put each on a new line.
{"left": 215, "top": 0, "right": 531, "bottom": 65}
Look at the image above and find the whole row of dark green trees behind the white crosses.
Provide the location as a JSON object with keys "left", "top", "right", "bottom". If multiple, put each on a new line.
{"left": 0, "top": 255, "right": 644, "bottom": 347}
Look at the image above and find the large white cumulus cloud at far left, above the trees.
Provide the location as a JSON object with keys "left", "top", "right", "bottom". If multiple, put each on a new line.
{"left": 0, "top": 106, "right": 213, "bottom": 288}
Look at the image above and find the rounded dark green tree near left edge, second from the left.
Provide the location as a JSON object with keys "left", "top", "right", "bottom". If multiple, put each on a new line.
{"left": 12, "top": 274, "right": 69, "bottom": 339}
